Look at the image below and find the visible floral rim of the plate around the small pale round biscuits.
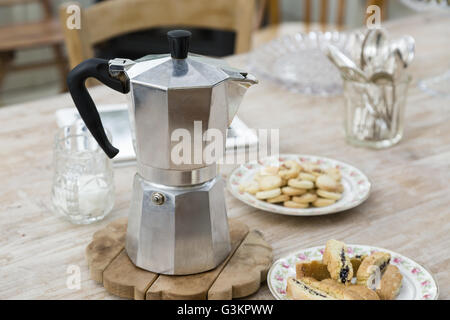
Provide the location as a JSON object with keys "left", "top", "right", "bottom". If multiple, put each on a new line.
{"left": 228, "top": 154, "right": 371, "bottom": 216}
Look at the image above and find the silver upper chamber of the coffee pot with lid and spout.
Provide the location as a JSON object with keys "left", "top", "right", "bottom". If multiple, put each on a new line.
{"left": 110, "top": 55, "right": 256, "bottom": 186}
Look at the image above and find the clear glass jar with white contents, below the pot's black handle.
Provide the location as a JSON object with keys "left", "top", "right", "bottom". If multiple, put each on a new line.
{"left": 52, "top": 121, "right": 114, "bottom": 224}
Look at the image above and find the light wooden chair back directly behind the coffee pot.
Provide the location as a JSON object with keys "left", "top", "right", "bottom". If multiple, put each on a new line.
{"left": 60, "top": 0, "right": 255, "bottom": 68}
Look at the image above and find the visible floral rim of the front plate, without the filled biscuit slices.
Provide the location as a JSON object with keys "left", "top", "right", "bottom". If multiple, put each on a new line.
{"left": 267, "top": 245, "right": 439, "bottom": 300}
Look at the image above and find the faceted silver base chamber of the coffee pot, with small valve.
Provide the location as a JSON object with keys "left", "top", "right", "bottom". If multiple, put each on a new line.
{"left": 126, "top": 174, "right": 231, "bottom": 275}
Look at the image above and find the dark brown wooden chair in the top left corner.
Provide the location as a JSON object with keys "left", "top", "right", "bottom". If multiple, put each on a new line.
{"left": 0, "top": 0, "right": 68, "bottom": 90}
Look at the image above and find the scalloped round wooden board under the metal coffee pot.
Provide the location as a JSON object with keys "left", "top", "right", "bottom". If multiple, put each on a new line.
{"left": 86, "top": 218, "right": 273, "bottom": 300}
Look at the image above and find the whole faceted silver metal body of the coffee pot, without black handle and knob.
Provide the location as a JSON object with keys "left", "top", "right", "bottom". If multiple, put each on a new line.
{"left": 109, "top": 54, "right": 257, "bottom": 275}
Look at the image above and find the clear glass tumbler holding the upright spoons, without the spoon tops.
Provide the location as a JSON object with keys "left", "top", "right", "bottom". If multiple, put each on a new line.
{"left": 344, "top": 76, "right": 411, "bottom": 149}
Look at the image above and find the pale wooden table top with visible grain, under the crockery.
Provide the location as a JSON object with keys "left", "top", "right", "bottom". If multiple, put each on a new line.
{"left": 0, "top": 14, "right": 450, "bottom": 299}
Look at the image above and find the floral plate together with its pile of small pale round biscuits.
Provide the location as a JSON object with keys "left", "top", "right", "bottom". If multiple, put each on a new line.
{"left": 228, "top": 154, "right": 371, "bottom": 216}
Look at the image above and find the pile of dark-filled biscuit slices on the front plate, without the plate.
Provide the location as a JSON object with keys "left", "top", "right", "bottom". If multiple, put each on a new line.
{"left": 286, "top": 240, "right": 403, "bottom": 300}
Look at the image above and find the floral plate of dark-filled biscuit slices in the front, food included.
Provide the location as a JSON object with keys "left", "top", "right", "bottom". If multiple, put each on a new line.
{"left": 267, "top": 240, "right": 439, "bottom": 300}
